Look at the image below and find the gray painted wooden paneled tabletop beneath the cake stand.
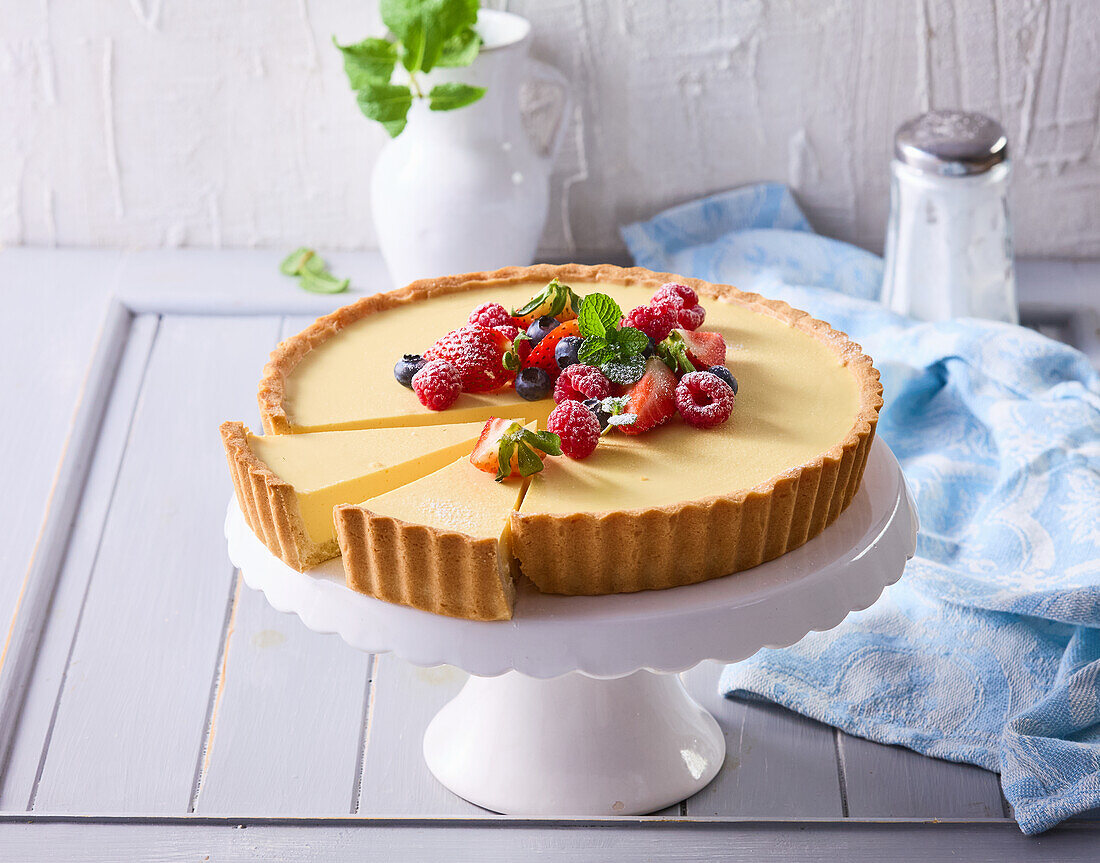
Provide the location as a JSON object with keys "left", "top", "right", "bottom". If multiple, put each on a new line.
{"left": 0, "top": 250, "right": 1100, "bottom": 861}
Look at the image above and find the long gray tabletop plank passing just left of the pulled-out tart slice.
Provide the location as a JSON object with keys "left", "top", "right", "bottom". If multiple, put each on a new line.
{"left": 34, "top": 317, "right": 278, "bottom": 812}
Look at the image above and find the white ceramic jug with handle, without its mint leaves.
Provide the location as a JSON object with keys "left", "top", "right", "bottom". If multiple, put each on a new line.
{"left": 371, "top": 9, "right": 570, "bottom": 286}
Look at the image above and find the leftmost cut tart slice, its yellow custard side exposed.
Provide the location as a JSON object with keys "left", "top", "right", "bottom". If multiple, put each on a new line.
{"left": 221, "top": 422, "right": 482, "bottom": 572}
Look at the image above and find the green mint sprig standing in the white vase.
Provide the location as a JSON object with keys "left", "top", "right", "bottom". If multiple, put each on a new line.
{"left": 332, "top": 0, "right": 485, "bottom": 137}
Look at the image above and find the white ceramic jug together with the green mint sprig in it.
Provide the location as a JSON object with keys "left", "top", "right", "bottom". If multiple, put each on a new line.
{"left": 338, "top": 0, "right": 570, "bottom": 286}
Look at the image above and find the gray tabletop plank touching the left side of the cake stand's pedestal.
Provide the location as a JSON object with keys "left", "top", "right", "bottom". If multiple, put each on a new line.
{"left": 358, "top": 654, "right": 485, "bottom": 816}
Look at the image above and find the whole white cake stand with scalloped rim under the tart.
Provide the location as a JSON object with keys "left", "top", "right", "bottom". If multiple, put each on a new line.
{"left": 226, "top": 440, "right": 917, "bottom": 816}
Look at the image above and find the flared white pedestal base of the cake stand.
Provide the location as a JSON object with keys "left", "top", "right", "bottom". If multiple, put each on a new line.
{"left": 424, "top": 671, "right": 726, "bottom": 816}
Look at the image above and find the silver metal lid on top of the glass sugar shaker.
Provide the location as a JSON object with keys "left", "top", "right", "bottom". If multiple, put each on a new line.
{"left": 894, "top": 111, "right": 1009, "bottom": 177}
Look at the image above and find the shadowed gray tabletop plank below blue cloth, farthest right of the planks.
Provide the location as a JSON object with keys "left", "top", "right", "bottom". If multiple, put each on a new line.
{"left": 838, "top": 733, "right": 1004, "bottom": 818}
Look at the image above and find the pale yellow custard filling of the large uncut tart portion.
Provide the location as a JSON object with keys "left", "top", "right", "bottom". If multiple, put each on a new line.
{"left": 277, "top": 283, "right": 859, "bottom": 512}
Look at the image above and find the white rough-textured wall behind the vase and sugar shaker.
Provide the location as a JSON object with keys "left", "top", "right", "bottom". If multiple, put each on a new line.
{"left": 0, "top": 0, "right": 1100, "bottom": 257}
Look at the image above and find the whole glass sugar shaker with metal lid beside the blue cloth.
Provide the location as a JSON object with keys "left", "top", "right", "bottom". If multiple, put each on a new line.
{"left": 882, "top": 111, "right": 1020, "bottom": 323}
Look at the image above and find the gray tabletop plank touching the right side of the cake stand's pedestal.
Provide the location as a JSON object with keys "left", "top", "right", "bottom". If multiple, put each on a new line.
{"left": 684, "top": 662, "right": 843, "bottom": 818}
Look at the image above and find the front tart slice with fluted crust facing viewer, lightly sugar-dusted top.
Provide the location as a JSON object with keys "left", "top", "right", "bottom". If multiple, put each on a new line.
{"left": 334, "top": 457, "right": 527, "bottom": 620}
